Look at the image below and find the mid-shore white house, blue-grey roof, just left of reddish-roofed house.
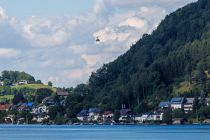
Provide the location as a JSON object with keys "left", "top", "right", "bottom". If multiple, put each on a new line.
{"left": 88, "top": 108, "right": 101, "bottom": 121}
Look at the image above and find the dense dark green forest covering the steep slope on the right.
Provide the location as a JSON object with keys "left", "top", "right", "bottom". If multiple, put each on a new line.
{"left": 63, "top": 0, "right": 210, "bottom": 117}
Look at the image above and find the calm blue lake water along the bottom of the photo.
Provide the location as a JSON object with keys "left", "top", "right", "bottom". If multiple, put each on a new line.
{"left": 0, "top": 125, "right": 210, "bottom": 140}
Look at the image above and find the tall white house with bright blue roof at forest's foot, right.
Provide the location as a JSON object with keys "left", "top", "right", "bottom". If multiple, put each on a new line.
{"left": 170, "top": 97, "right": 185, "bottom": 111}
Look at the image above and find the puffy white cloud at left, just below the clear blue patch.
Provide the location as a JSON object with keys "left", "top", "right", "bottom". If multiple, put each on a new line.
{"left": 22, "top": 17, "right": 70, "bottom": 47}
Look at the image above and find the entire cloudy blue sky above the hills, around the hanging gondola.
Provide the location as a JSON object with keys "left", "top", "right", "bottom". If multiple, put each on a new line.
{"left": 0, "top": 0, "right": 196, "bottom": 87}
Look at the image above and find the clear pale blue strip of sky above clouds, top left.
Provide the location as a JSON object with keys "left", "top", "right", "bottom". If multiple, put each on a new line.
{"left": 0, "top": 0, "right": 95, "bottom": 18}
